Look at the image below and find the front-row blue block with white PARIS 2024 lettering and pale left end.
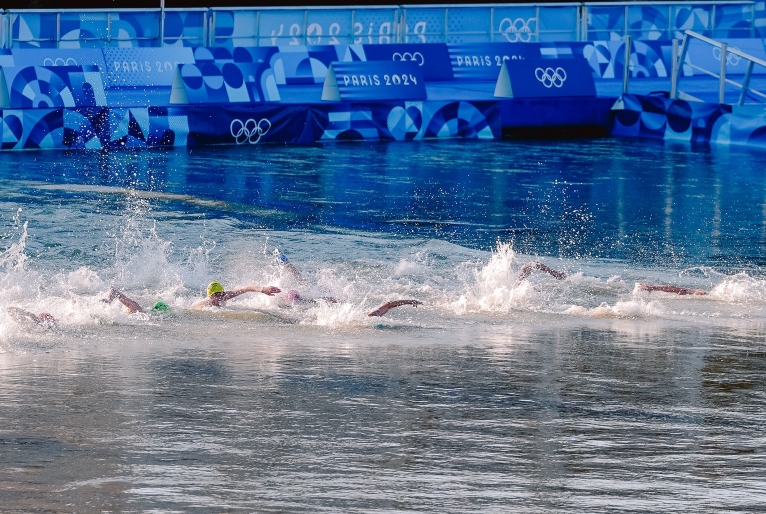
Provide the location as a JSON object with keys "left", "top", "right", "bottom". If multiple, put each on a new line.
{"left": 322, "top": 61, "right": 426, "bottom": 101}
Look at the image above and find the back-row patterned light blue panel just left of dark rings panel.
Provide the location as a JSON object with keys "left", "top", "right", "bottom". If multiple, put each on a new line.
{"left": 270, "top": 45, "right": 345, "bottom": 85}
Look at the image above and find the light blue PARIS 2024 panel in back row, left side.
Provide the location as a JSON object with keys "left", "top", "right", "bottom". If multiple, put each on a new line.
{"left": 104, "top": 47, "right": 194, "bottom": 88}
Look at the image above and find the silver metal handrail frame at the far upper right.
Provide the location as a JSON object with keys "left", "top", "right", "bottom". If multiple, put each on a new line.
{"left": 670, "top": 30, "right": 766, "bottom": 105}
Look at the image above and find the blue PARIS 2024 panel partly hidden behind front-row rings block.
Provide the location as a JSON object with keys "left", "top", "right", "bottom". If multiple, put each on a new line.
{"left": 447, "top": 43, "right": 540, "bottom": 80}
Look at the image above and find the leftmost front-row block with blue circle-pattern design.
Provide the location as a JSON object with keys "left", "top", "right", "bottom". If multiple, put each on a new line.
{"left": 2, "top": 66, "right": 106, "bottom": 109}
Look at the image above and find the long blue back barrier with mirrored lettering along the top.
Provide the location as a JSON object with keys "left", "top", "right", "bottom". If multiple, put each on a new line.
{"left": 0, "top": 0, "right": 766, "bottom": 48}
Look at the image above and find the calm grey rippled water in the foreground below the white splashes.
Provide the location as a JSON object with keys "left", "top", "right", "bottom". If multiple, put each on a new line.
{"left": 0, "top": 326, "right": 766, "bottom": 512}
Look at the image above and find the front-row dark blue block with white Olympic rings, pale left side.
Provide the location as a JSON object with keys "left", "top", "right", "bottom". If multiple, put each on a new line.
{"left": 495, "top": 58, "right": 596, "bottom": 98}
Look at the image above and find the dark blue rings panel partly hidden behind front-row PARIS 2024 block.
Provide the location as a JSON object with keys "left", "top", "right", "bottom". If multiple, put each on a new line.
{"left": 362, "top": 43, "right": 452, "bottom": 80}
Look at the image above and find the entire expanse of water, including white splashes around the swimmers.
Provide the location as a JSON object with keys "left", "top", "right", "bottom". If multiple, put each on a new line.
{"left": 0, "top": 140, "right": 766, "bottom": 512}
